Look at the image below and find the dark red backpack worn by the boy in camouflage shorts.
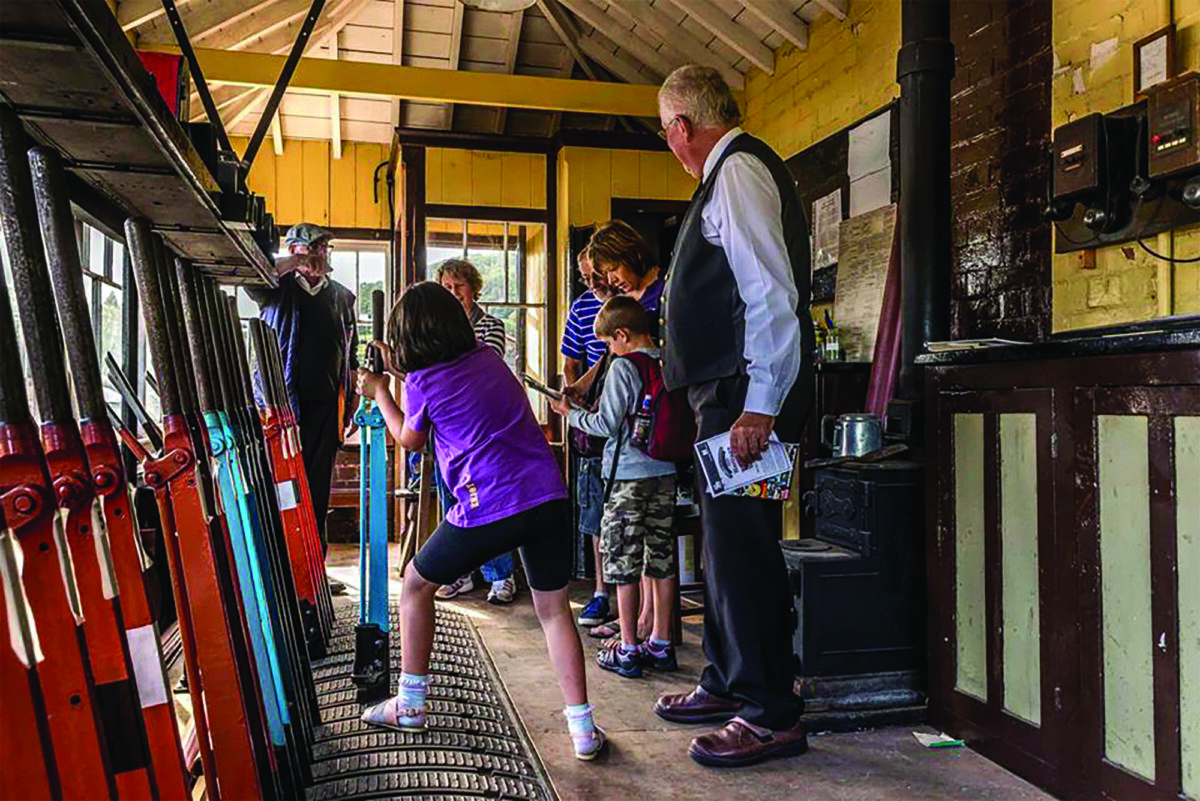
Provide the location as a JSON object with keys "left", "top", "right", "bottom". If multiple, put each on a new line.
{"left": 618, "top": 351, "right": 696, "bottom": 462}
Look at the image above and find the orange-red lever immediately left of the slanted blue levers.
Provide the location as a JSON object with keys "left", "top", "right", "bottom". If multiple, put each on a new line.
{"left": 125, "top": 219, "right": 270, "bottom": 799}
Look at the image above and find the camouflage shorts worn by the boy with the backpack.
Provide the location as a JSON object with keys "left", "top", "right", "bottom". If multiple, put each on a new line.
{"left": 600, "top": 476, "right": 676, "bottom": 584}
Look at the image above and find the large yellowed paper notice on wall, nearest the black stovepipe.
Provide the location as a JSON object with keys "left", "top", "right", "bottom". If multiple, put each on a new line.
{"left": 834, "top": 205, "right": 896, "bottom": 361}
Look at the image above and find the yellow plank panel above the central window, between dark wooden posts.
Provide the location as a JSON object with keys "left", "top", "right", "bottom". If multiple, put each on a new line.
{"left": 425, "top": 147, "right": 546, "bottom": 209}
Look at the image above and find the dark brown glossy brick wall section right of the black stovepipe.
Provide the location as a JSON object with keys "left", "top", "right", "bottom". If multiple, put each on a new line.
{"left": 950, "top": 0, "right": 1054, "bottom": 342}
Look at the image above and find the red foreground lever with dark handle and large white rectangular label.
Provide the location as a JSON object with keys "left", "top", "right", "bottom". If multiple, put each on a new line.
{"left": 29, "top": 147, "right": 191, "bottom": 800}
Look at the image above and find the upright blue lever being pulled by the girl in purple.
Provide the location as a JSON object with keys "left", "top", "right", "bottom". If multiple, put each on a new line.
{"left": 352, "top": 289, "right": 391, "bottom": 701}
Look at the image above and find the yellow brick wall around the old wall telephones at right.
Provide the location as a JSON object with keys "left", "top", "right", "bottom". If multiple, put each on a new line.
{"left": 1051, "top": 0, "right": 1200, "bottom": 331}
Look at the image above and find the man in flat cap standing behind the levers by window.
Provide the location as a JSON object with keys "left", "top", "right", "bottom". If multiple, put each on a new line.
{"left": 246, "top": 223, "right": 359, "bottom": 592}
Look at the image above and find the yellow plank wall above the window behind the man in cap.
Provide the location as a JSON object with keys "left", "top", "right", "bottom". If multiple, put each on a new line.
{"left": 232, "top": 138, "right": 391, "bottom": 229}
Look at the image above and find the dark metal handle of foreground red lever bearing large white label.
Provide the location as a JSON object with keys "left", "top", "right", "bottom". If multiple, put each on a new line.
{"left": 29, "top": 147, "right": 108, "bottom": 429}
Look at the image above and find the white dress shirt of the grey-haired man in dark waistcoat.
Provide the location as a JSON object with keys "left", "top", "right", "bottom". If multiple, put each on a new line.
{"left": 701, "top": 128, "right": 803, "bottom": 417}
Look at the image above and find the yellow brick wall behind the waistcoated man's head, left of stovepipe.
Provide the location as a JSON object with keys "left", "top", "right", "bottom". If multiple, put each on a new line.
{"left": 743, "top": 0, "right": 900, "bottom": 158}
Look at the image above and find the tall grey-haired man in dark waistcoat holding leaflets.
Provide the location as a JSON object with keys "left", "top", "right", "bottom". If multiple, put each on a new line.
{"left": 654, "top": 66, "right": 815, "bottom": 766}
